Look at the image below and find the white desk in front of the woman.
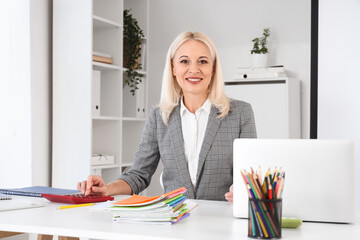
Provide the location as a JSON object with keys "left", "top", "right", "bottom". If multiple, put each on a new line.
{"left": 0, "top": 197, "right": 360, "bottom": 240}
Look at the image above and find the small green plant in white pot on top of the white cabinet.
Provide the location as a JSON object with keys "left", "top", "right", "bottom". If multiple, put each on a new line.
{"left": 251, "top": 28, "right": 270, "bottom": 68}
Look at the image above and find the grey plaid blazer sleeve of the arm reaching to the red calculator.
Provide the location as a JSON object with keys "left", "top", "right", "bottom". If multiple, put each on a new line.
{"left": 119, "top": 107, "right": 160, "bottom": 194}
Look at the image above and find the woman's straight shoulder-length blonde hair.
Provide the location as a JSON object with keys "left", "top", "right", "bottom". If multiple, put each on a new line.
{"left": 159, "top": 32, "right": 230, "bottom": 125}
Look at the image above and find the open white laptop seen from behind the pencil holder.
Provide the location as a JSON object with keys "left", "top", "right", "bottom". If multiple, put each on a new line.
{"left": 233, "top": 139, "right": 355, "bottom": 223}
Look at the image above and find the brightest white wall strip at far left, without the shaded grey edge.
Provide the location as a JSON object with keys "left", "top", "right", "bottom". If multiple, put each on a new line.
{"left": 0, "top": 0, "right": 31, "bottom": 187}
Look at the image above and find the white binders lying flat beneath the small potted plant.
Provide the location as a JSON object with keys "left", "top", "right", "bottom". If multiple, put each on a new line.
{"left": 234, "top": 65, "right": 286, "bottom": 80}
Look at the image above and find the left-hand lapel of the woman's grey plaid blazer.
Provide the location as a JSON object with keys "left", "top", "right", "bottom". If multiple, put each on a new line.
{"left": 169, "top": 105, "right": 195, "bottom": 198}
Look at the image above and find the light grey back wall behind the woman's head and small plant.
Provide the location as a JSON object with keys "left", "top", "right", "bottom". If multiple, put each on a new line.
{"left": 149, "top": 0, "right": 311, "bottom": 138}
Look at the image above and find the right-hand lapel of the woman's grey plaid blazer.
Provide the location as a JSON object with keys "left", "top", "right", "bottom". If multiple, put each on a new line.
{"left": 195, "top": 106, "right": 221, "bottom": 192}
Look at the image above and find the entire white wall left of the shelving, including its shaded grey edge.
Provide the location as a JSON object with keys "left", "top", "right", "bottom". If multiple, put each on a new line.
{"left": 0, "top": 0, "right": 51, "bottom": 187}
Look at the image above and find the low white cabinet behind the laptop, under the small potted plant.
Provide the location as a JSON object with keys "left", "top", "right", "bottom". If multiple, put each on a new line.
{"left": 225, "top": 78, "right": 301, "bottom": 138}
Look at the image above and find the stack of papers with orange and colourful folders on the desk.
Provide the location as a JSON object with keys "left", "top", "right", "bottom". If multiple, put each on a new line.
{"left": 108, "top": 187, "right": 197, "bottom": 224}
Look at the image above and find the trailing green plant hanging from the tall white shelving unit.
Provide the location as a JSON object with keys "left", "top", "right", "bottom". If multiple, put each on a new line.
{"left": 123, "top": 9, "right": 144, "bottom": 95}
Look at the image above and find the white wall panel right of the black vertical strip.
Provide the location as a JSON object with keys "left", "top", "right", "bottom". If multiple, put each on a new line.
{"left": 318, "top": 0, "right": 360, "bottom": 216}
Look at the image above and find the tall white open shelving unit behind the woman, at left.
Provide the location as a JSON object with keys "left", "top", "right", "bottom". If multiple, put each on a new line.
{"left": 52, "top": 0, "right": 149, "bottom": 188}
